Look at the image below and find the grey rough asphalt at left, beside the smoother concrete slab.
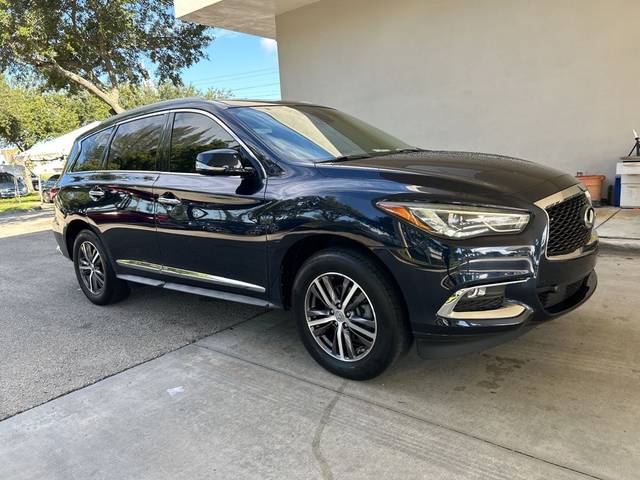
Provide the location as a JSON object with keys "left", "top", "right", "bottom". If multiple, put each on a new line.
{"left": 0, "top": 227, "right": 262, "bottom": 420}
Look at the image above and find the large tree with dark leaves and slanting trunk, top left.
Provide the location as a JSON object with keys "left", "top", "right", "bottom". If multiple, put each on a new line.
{"left": 0, "top": 0, "right": 213, "bottom": 113}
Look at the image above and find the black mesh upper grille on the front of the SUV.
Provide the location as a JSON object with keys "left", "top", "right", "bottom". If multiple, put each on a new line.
{"left": 547, "top": 194, "right": 591, "bottom": 257}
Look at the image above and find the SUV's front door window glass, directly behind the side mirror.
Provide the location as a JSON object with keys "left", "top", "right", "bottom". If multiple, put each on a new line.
{"left": 169, "top": 113, "right": 238, "bottom": 173}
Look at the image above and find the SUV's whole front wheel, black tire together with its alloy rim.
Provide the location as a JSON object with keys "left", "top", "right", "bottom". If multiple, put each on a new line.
{"left": 292, "top": 249, "right": 411, "bottom": 380}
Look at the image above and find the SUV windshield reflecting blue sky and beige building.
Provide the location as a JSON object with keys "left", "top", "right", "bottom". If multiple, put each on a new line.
{"left": 229, "top": 105, "right": 411, "bottom": 162}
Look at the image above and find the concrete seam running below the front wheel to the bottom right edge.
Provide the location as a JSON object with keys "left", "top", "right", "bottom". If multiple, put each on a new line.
{"left": 193, "top": 343, "right": 606, "bottom": 480}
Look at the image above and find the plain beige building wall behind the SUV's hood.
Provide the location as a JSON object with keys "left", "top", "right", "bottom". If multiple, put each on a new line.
{"left": 276, "top": 0, "right": 640, "bottom": 193}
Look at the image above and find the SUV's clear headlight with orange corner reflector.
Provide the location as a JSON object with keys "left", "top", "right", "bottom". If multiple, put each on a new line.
{"left": 377, "top": 201, "right": 530, "bottom": 238}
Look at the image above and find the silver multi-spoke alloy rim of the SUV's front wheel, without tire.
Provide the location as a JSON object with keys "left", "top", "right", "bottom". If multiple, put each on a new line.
{"left": 305, "top": 272, "right": 377, "bottom": 362}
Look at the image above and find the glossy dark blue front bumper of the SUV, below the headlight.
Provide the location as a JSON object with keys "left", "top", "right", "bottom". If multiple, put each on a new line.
{"left": 375, "top": 215, "right": 598, "bottom": 358}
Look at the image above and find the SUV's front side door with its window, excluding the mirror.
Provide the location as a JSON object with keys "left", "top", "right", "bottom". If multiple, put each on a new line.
{"left": 154, "top": 111, "right": 267, "bottom": 298}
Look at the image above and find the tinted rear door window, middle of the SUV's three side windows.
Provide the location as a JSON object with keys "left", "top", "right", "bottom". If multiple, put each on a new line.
{"left": 107, "top": 115, "right": 165, "bottom": 171}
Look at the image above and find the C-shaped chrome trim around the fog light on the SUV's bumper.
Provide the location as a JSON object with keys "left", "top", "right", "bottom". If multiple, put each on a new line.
{"left": 437, "top": 279, "right": 529, "bottom": 326}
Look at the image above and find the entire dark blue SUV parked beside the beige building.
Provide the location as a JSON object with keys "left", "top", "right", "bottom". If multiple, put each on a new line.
{"left": 53, "top": 99, "right": 598, "bottom": 379}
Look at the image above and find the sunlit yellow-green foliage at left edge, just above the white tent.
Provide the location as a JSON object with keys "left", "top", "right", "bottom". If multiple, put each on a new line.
{"left": 0, "top": 77, "right": 109, "bottom": 151}
